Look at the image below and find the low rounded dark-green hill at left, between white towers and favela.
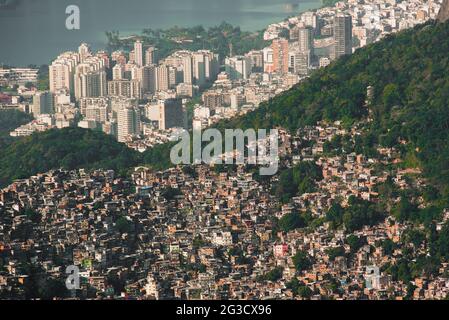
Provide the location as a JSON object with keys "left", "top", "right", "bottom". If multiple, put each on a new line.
{"left": 0, "top": 128, "right": 141, "bottom": 186}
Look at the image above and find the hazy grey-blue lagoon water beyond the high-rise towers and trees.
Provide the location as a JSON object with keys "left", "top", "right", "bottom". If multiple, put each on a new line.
{"left": 0, "top": 0, "right": 321, "bottom": 66}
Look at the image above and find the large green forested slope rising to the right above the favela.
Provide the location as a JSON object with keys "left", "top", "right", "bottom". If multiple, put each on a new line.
{"left": 225, "top": 23, "right": 449, "bottom": 130}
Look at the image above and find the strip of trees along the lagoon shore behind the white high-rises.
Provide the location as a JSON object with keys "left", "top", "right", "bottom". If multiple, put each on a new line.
{"left": 106, "top": 22, "right": 269, "bottom": 60}
